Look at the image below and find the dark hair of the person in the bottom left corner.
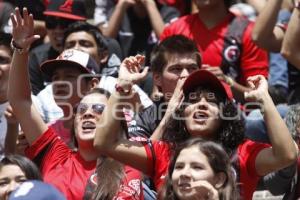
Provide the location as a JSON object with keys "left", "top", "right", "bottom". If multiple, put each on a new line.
{"left": 0, "top": 154, "right": 42, "bottom": 180}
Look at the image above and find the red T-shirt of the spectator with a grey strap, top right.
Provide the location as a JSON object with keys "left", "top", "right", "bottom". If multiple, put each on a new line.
{"left": 160, "top": 13, "right": 268, "bottom": 85}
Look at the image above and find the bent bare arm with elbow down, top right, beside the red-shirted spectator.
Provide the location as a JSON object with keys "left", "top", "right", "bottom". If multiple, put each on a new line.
{"left": 252, "top": 0, "right": 284, "bottom": 52}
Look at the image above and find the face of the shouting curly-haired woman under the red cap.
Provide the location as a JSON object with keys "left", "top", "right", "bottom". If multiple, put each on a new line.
{"left": 184, "top": 91, "right": 222, "bottom": 139}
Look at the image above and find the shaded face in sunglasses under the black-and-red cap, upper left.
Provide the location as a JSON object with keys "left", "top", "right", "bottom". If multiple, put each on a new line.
{"left": 45, "top": 16, "right": 75, "bottom": 52}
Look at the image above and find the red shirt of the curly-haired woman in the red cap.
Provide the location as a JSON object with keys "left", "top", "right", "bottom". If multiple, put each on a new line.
{"left": 144, "top": 140, "right": 270, "bottom": 200}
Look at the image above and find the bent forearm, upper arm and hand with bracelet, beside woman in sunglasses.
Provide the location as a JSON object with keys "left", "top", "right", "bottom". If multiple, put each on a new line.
{"left": 94, "top": 56, "right": 149, "bottom": 173}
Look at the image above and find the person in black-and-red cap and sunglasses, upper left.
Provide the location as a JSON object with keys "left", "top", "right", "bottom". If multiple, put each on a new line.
{"left": 29, "top": 0, "right": 86, "bottom": 95}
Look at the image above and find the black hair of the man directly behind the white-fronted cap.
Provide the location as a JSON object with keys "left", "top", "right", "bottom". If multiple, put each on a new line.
{"left": 63, "top": 21, "right": 108, "bottom": 55}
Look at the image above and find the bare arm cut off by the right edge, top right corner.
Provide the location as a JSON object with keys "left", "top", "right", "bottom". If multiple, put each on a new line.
{"left": 281, "top": 1, "right": 300, "bottom": 70}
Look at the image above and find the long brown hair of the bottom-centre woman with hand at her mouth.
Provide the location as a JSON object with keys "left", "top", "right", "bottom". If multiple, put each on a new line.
{"left": 159, "top": 138, "right": 239, "bottom": 200}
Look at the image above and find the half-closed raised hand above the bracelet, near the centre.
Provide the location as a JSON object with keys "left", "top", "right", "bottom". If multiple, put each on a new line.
{"left": 118, "top": 55, "right": 149, "bottom": 88}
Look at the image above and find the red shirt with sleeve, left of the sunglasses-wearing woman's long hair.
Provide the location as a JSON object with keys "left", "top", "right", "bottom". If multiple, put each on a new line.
{"left": 25, "top": 128, "right": 96, "bottom": 200}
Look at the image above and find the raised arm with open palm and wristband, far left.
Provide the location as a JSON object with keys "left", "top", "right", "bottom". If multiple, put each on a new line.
{"left": 8, "top": 8, "right": 47, "bottom": 144}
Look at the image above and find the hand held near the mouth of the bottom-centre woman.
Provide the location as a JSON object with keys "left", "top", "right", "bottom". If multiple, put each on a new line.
{"left": 191, "top": 180, "right": 219, "bottom": 200}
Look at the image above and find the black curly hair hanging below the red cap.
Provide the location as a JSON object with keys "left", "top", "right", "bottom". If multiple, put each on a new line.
{"left": 162, "top": 86, "right": 245, "bottom": 155}
